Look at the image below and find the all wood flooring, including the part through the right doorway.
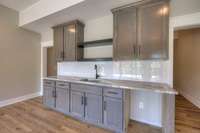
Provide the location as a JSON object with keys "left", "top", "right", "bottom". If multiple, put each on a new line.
{"left": 0, "top": 96, "right": 200, "bottom": 133}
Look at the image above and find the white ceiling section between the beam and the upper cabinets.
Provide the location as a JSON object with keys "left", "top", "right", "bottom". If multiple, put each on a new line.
{"left": 23, "top": 0, "right": 139, "bottom": 33}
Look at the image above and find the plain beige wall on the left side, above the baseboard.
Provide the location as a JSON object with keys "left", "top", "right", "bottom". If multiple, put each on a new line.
{"left": 0, "top": 5, "right": 41, "bottom": 102}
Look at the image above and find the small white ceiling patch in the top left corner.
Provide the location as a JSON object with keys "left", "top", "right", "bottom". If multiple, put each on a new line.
{"left": 0, "top": 0, "right": 40, "bottom": 11}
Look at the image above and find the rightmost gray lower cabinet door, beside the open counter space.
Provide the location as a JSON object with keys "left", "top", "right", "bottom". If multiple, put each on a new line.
{"left": 104, "top": 97, "right": 123, "bottom": 131}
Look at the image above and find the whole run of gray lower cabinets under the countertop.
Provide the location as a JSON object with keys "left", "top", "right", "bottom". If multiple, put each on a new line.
{"left": 43, "top": 80, "right": 130, "bottom": 133}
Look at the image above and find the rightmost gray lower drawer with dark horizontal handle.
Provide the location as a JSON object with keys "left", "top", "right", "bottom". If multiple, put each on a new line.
{"left": 103, "top": 88, "right": 123, "bottom": 98}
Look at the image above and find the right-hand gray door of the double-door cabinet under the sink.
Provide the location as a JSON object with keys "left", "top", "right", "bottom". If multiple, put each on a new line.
{"left": 85, "top": 93, "right": 103, "bottom": 124}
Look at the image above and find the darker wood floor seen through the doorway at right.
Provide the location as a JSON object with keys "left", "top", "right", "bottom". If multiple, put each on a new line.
{"left": 176, "top": 96, "right": 200, "bottom": 133}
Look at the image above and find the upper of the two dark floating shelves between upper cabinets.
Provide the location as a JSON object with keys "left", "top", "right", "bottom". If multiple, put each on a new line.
{"left": 78, "top": 38, "right": 113, "bottom": 48}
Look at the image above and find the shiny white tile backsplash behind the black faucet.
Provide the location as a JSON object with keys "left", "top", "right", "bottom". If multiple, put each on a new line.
{"left": 58, "top": 61, "right": 168, "bottom": 82}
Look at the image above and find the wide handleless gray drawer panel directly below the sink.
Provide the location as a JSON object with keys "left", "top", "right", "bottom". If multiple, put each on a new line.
{"left": 71, "top": 84, "right": 102, "bottom": 95}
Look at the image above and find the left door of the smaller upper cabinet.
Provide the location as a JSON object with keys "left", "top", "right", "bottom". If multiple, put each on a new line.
{"left": 54, "top": 27, "right": 64, "bottom": 61}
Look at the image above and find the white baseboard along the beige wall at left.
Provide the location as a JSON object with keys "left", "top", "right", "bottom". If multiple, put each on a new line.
{"left": 0, "top": 92, "right": 41, "bottom": 108}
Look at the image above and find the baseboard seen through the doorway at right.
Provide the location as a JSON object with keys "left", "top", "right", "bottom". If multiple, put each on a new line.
{"left": 180, "top": 90, "right": 200, "bottom": 108}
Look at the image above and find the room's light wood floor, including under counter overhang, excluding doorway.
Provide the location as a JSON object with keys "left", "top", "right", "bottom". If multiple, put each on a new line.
{"left": 0, "top": 98, "right": 161, "bottom": 133}
